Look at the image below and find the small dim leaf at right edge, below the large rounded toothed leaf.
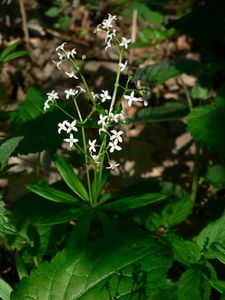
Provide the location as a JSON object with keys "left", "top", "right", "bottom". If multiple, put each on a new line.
{"left": 204, "top": 165, "right": 225, "bottom": 191}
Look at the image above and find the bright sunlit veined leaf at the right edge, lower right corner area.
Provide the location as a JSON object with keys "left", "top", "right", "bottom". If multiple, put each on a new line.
{"left": 194, "top": 215, "right": 225, "bottom": 258}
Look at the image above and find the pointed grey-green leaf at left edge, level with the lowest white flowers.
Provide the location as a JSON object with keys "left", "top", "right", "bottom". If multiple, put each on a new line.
{"left": 0, "top": 136, "right": 23, "bottom": 171}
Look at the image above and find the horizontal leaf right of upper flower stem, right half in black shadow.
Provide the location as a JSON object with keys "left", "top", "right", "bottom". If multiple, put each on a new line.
{"left": 134, "top": 59, "right": 203, "bottom": 84}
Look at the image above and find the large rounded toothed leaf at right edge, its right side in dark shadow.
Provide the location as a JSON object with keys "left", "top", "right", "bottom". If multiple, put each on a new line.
{"left": 188, "top": 105, "right": 225, "bottom": 155}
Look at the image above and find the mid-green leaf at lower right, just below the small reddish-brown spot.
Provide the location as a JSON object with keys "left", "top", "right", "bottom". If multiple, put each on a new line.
{"left": 164, "top": 234, "right": 201, "bottom": 266}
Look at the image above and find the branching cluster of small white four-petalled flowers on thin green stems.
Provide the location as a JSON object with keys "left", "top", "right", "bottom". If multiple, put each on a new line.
{"left": 44, "top": 14, "right": 147, "bottom": 169}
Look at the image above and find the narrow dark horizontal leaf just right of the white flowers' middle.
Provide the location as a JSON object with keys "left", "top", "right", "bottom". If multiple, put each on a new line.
{"left": 133, "top": 102, "right": 189, "bottom": 122}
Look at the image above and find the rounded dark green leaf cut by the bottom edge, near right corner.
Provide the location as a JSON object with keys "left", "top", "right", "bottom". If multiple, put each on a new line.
{"left": 178, "top": 266, "right": 211, "bottom": 300}
